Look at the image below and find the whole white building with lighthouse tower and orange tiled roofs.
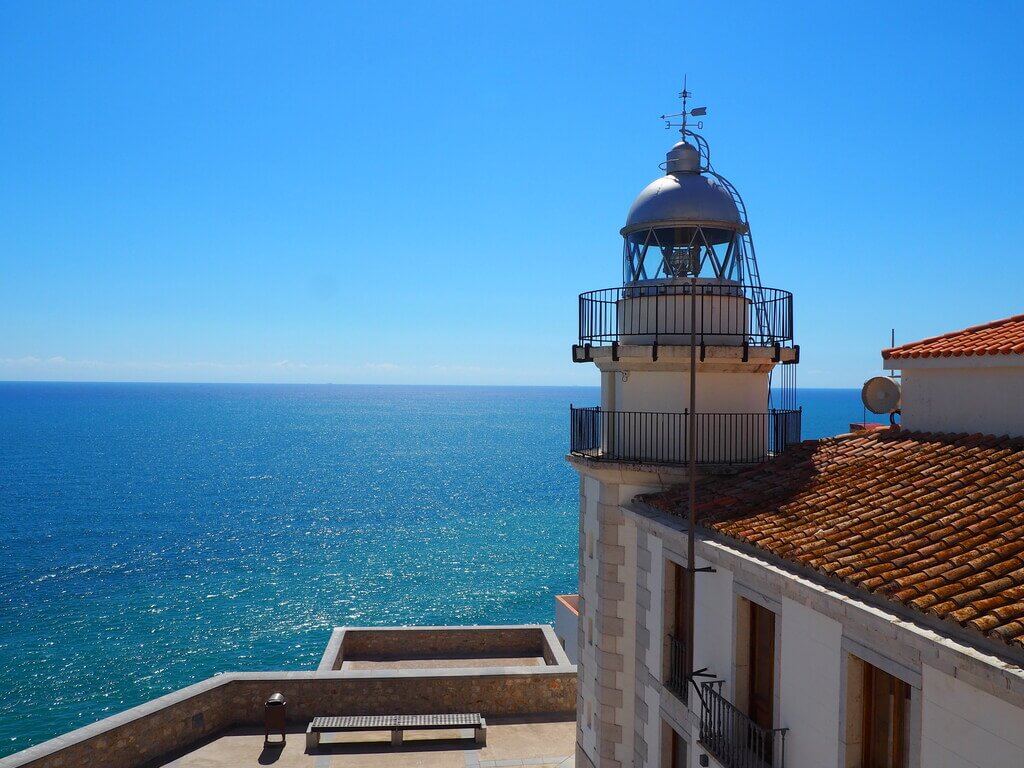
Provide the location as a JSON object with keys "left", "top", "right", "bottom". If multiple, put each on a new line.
{"left": 562, "top": 96, "right": 1024, "bottom": 768}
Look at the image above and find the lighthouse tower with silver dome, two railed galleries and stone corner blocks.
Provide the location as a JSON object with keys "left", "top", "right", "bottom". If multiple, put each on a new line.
{"left": 568, "top": 89, "right": 800, "bottom": 768}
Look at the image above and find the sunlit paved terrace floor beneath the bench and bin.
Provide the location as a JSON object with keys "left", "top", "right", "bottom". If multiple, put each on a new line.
{"left": 151, "top": 718, "right": 575, "bottom": 768}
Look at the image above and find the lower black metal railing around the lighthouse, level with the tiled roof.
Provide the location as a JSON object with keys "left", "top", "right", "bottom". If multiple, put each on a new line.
{"left": 569, "top": 407, "right": 802, "bottom": 465}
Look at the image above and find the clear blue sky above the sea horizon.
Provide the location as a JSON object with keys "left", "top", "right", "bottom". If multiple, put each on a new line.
{"left": 0, "top": 2, "right": 1024, "bottom": 386}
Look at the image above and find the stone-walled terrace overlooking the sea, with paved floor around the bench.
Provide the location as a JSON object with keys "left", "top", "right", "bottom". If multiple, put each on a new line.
{"left": 0, "top": 625, "right": 577, "bottom": 768}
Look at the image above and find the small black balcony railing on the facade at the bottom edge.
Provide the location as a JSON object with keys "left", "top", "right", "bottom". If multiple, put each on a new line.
{"left": 700, "top": 680, "right": 788, "bottom": 768}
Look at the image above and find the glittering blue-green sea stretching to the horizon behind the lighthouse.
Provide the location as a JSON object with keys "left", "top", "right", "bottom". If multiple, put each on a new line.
{"left": 0, "top": 383, "right": 862, "bottom": 756}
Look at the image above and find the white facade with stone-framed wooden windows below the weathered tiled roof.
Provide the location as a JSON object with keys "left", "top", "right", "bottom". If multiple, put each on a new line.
{"left": 578, "top": 493, "right": 1024, "bottom": 768}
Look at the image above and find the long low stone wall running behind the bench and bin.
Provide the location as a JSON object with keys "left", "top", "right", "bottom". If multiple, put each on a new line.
{"left": 0, "top": 666, "right": 577, "bottom": 768}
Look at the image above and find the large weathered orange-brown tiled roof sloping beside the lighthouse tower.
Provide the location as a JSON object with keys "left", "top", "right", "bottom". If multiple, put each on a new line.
{"left": 642, "top": 429, "right": 1024, "bottom": 650}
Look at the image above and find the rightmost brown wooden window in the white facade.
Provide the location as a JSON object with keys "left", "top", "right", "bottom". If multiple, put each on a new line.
{"left": 846, "top": 655, "right": 910, "bottom": 768}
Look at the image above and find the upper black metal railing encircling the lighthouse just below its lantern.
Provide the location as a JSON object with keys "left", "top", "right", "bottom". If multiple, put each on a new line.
{"left": 580, "top": 284, "right": 793, "bottom": 346}
